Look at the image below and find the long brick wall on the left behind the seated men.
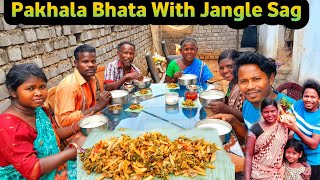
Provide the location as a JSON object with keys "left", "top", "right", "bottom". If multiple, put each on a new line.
{"left": 0, "top": 15, "right": 152, "bottom": 112}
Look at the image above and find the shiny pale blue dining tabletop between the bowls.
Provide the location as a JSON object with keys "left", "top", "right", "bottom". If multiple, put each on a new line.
{"left": 77, "top": 83, "right": 244, "bottom": 179}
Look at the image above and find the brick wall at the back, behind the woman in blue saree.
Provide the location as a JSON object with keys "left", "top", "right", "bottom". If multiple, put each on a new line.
{"left": 162, "top": 25, "right": 242, "bottom": 60}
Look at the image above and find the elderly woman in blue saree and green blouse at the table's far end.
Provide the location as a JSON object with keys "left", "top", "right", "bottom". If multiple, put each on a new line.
{"left": 165, "top": 37, "right": 213, "bottom": 84}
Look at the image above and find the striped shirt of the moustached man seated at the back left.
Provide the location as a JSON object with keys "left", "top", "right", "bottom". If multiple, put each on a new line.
{"left": 104, "top": 58, "right": 140, "bottom": 83}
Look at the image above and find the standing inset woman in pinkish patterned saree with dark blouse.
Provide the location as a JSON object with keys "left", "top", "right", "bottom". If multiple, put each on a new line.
{"left": 245, "top": 98, "right": 288, "bottom": 180}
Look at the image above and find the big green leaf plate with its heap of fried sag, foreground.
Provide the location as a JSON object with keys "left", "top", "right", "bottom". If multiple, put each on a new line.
{"left": 77, "top": 129, "right": 234, "bottom": 180}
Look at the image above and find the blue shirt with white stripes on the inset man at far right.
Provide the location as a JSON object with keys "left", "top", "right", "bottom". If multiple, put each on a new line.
{"left": 291, "top": 100, "right": 320, "bottom": 166}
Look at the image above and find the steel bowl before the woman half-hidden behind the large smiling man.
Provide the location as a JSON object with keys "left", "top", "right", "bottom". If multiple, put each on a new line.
{"left": 199, "top": 89, "right": 226, "bottom": 107}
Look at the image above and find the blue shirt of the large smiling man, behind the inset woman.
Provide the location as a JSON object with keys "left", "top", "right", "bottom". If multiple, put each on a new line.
{"left": 242, "top": 91, "right": 295, "bottom": 129}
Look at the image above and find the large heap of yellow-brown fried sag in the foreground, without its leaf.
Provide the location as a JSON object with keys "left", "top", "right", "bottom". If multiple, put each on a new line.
{"left": 80, "top": 132, "right": 221, "bottom": 180}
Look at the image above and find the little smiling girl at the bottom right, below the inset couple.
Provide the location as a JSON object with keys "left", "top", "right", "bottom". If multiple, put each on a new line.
{"left": 284, "top": 139, "right": 309, "bottom": 180}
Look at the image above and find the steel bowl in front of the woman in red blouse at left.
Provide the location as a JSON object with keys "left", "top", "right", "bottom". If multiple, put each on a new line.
{"left": 79, "top": 115, "right": 108, "bottom": 136}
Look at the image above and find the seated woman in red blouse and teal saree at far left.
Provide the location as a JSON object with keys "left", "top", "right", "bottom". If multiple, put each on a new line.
{"left": 0, "top": 64, "right": 83, "bottom": 180}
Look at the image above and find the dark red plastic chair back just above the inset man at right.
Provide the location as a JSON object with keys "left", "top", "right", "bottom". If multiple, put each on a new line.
{"left": 277, "top": 82, "right": 303, "bottom": 100}
